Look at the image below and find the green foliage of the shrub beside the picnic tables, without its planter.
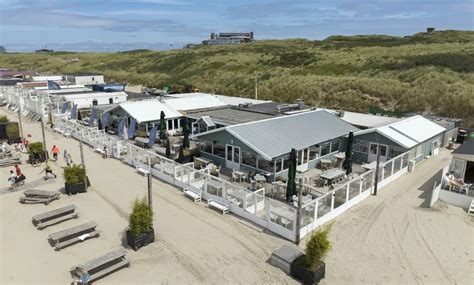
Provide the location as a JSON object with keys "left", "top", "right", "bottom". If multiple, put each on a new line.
{"left": 128, "top": 197, "right": 153, "bottom": 236}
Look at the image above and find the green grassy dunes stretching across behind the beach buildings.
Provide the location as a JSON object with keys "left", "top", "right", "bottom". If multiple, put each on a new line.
{"left": 0, "top": 31, "right": 474, "bottom": 127}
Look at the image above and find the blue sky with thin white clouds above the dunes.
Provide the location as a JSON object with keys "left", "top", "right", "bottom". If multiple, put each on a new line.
{"left": 0, "top": 0, "right": 474, "bottom": 52}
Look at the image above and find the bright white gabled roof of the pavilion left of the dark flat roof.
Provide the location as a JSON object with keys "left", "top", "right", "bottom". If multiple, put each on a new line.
{"left": 115, "top": 99, "right": 181, "bottom": 123}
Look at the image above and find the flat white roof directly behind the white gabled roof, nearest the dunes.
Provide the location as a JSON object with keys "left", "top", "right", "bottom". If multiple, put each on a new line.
{"left": 163, "top": 93, "right": 226, "bottom": 111}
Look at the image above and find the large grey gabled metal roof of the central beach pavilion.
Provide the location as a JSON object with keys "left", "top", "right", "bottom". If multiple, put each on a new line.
{"left": 198, "top": 111, "right": 358, "bottom": 160}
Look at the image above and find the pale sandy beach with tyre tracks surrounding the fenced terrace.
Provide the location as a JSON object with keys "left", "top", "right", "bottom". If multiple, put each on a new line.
{"left": 0, "top": 105, "right": 474, "bottom": 284}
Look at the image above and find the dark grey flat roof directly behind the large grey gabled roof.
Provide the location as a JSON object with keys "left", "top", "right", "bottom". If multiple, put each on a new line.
{"left": 186, "top": 107, "right": 273, "bottom": 126}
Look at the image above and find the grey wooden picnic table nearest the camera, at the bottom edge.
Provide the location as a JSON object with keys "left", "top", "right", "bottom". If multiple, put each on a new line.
{"left": 70, "top": 249, "right": 130, "bottom": 282}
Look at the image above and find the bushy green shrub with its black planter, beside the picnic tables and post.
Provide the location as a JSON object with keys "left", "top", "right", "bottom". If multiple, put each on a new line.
{"left": 127, "top": 198, "right": 155, "bottom": 250}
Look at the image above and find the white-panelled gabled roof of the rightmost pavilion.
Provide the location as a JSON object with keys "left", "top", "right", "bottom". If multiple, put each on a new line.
{"left": 357, "top": 115, "right": 446, "bottom": 148}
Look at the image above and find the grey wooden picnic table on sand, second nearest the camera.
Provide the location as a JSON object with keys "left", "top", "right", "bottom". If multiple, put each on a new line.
{"left": 48, "top": 221, "right": 100, "bottom": 250}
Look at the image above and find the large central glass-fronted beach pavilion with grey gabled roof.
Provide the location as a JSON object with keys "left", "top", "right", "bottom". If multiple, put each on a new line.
{"left": 195, "top": 111, "right": 358, "bottom": 181}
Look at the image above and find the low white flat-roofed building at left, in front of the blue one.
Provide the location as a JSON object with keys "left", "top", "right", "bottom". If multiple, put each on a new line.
{"left": 65, "top": 92, "right": 128, "bottom": 109}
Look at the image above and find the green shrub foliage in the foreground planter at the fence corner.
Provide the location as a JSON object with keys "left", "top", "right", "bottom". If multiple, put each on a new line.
{"left": 305, "top": 223, "right": 333, "bottom": 270}
